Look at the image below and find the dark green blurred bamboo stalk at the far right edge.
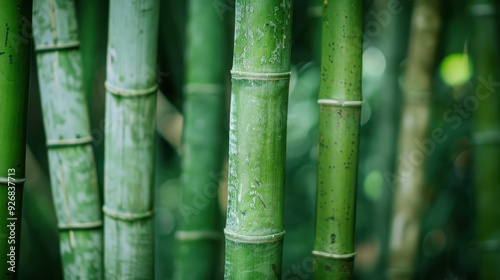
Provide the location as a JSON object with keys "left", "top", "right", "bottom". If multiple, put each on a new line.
{"left": 469, "top": 0, "right": 500, "bottom": 279}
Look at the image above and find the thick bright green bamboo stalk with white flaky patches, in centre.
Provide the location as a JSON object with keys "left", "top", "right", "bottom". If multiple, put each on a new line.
{"left": 224, "top": 0, "right": 292, "bottom": 279}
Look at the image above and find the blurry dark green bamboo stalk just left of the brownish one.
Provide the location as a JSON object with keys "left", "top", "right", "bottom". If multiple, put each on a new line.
{"left": 362, "top": 0, "right": 410, "bottom": 275}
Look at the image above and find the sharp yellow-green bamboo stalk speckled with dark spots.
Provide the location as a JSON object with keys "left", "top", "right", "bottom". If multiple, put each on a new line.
{"left": 313, "top": 0, "right": 363, "bottom": 279}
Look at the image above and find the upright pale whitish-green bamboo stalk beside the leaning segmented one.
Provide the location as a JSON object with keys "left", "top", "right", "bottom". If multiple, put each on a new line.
{"left": 103, "top": 0, "right": 159, "bottom": 279}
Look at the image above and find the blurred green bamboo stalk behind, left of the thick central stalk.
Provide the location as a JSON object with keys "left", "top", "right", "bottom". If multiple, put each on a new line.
{"left": 175, "top": 0, "right": 227, "bottom": 279}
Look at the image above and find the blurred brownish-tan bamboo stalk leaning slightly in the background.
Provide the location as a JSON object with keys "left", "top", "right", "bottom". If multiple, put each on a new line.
{"left": 388, "top": 0, "right": 440, "bottom": 279}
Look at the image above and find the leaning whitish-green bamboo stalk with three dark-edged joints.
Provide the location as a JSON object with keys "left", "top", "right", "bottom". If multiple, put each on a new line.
{"left": 33, "top": 0, "right": 103, "bottom": 279}
